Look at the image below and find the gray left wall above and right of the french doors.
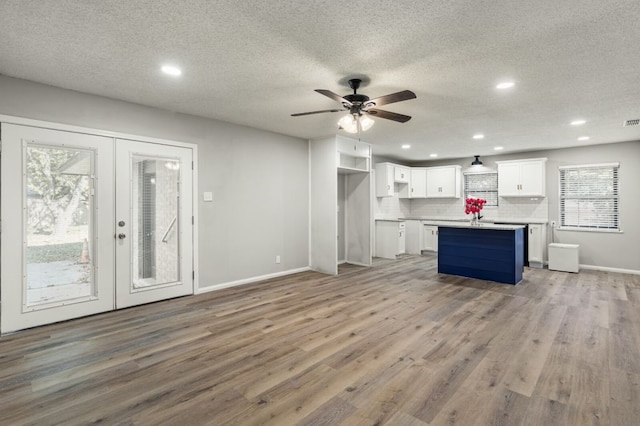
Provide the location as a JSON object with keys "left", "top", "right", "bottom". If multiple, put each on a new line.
{"left": 0, "top": 76, "right": 309, "bottom": 288}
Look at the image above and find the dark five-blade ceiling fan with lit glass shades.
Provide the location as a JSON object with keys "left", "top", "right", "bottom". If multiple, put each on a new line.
{"left": 291, "top": 78, "right": 416, "bottom": 133}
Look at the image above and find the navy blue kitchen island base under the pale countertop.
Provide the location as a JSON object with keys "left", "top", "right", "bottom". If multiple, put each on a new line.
{"left": 438, "top": 226, "right": 524, "bottom": 284}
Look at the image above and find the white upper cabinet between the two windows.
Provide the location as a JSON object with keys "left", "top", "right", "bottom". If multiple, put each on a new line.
{"left": 496, "top": 158, "right": 547, "bottom": 197}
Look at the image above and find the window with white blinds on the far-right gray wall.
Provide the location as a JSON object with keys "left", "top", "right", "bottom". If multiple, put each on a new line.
{"left": 560, "top": 163, "right": 620, "bottom": 231}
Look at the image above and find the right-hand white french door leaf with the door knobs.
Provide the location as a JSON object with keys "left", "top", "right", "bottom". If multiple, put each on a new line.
{"left": 114, "top": 139, "right": 193, "bottom": 308}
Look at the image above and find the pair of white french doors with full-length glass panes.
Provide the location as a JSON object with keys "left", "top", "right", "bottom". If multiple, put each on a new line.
{"left": 0, "top": 123, "right": 193, "bottom": 333}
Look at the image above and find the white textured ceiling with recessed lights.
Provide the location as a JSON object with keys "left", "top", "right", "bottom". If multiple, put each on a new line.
{"left": 0, "top": 0, "right": 640, "bottom": 161}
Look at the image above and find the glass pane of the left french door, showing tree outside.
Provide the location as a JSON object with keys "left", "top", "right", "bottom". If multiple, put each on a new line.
{"left": 23, "top": 143, "right": 96, "bottom": 309}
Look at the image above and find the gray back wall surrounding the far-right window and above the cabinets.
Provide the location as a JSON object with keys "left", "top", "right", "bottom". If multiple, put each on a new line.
{"left": 412, "top": 141, "right": 640, "bottom": 271}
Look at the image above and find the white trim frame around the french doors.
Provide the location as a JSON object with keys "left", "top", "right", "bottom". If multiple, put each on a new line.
{"left": 0, "top": 114, "right": 199, "bottom": 330}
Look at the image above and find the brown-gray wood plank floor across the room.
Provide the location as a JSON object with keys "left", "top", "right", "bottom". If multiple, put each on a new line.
{"left": 0, "top": 256, "right": 640, "bottom": 426}
